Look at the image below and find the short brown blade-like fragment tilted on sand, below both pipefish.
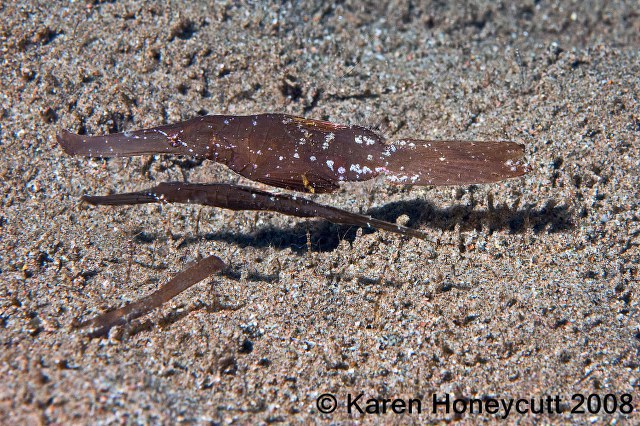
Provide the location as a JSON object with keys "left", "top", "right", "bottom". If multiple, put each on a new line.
{"left": 79, "top": 256, "right": 224, "bottom": 337}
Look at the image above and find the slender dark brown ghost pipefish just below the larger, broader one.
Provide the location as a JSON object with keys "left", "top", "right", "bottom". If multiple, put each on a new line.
{"left": 82, "top": 182, "right": 427, "bottom": 239}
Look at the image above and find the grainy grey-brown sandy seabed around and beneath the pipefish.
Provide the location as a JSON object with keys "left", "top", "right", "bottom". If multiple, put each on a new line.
{"left": 0, "top": 0, "right": 640, "bottom": 424}
